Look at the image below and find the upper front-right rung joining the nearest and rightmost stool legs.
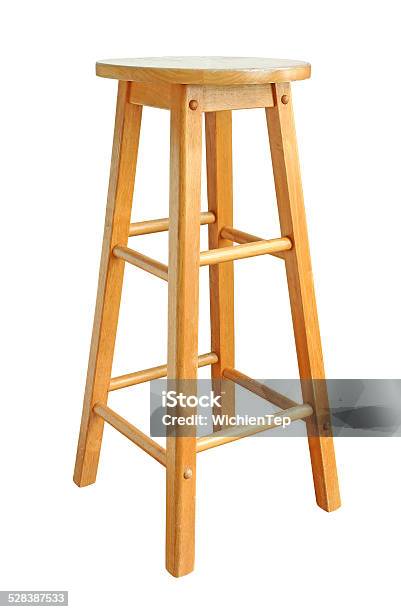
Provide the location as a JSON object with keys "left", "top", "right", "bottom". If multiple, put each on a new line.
{"left": 200, "top": 236, "right": 292, "bottom": 266}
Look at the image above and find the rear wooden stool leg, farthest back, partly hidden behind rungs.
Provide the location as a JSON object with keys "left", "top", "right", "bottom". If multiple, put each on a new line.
{"left": 205, "top": 111, "right": 235, "bottom": 430}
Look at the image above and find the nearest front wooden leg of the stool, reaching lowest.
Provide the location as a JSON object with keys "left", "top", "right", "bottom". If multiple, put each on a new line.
{"left": 166, "top": 86, "right": 202, "bottom": 576}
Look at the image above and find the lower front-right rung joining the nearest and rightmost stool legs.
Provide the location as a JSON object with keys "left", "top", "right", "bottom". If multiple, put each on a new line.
{"left": 196, "top": 404, "right": 313, "bottom": 453}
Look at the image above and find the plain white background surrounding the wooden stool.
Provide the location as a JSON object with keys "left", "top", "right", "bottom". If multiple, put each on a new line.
{"left": 0, "top": 0, "right": 401, "bottom": 612}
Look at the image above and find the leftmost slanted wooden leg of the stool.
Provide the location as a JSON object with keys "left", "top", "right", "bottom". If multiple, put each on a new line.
{"left": 74, "top": 82, "right": 142, "bottom": 487}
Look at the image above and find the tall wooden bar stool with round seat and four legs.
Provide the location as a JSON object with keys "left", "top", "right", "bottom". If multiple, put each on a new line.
{"left": 74, "top": 57, "right": 340, "bottom": 576}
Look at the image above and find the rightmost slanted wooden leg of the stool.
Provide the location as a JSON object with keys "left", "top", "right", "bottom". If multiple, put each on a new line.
{"left": 266, "top": 83, "right": 341, "bottom": 512}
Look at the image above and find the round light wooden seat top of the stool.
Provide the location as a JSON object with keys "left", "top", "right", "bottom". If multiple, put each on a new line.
{"left": 96, "top": 57, "right": 311, "bottom": 85}
